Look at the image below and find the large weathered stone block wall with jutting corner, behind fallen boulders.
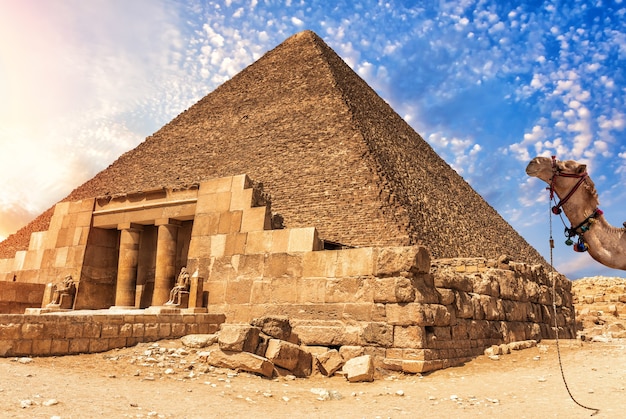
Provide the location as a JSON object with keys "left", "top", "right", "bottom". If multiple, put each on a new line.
{"left": 205, "top": 246, "right": 575, "bottom": 373}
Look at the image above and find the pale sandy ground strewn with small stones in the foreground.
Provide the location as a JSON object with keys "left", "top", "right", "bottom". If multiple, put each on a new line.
{"left": 0, "top": 339, "right": 626, "bottom": 419}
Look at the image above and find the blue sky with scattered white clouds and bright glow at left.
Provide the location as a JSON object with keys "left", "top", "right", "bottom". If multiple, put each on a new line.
{"left": 0, "top": 0, "right": 626, "bottom": 279}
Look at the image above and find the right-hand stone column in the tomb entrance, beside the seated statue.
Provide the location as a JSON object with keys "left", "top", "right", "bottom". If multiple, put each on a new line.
{"left": 152, "top": 218, "right": 180, "bottom": 306}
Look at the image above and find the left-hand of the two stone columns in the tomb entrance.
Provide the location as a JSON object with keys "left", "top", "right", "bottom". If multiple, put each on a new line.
{"left": 115, "top": 223, "right": 142, "bottom": 308}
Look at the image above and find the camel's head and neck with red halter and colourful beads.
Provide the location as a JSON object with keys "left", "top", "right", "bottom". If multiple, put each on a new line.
{"left": 526, "top": 157, "right": 626, "bottom": 270}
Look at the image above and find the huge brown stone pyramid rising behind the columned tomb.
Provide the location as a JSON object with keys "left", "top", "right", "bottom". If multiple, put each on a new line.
{"left": 0, "top": 31, "right": 545, "bottom": 263}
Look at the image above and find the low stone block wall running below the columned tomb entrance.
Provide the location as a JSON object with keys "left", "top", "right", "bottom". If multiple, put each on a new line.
{"left": 0, "top": 311, "right": 224, "bottom": 356}
